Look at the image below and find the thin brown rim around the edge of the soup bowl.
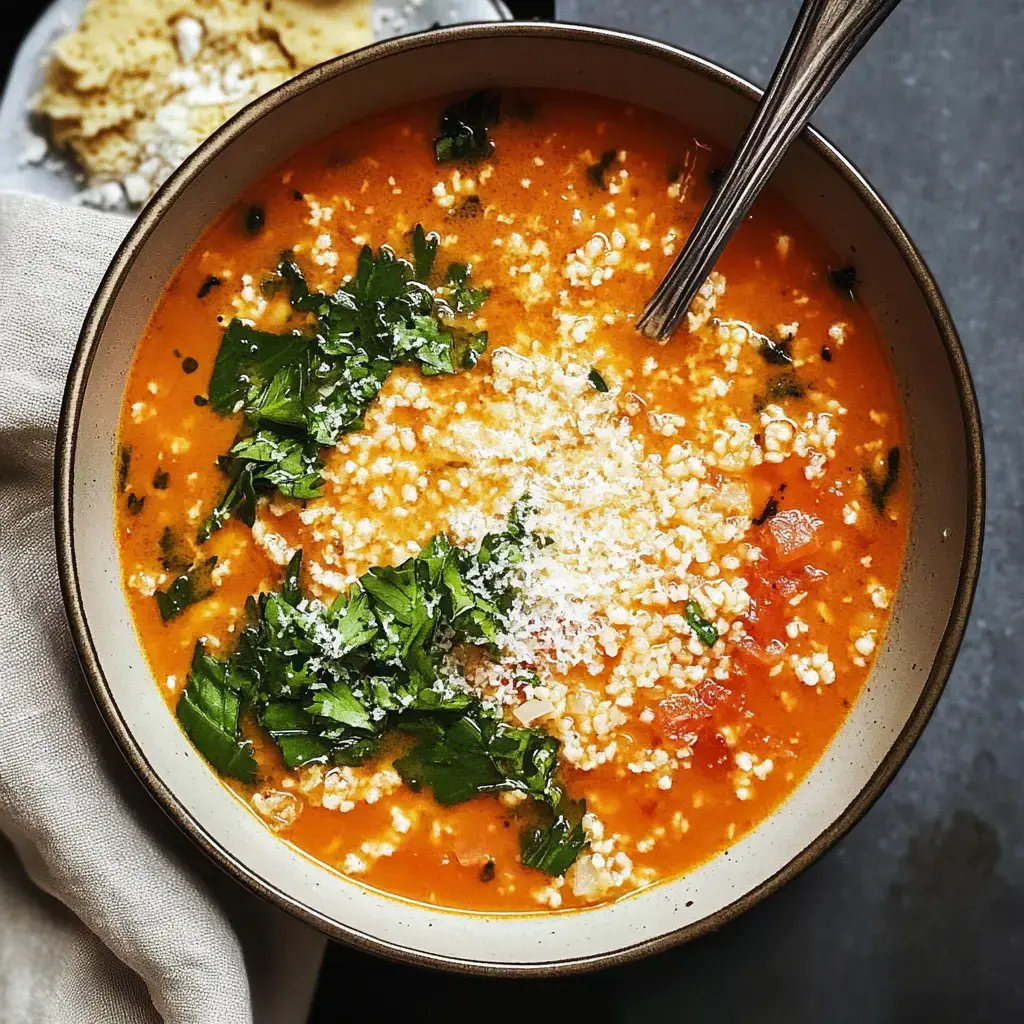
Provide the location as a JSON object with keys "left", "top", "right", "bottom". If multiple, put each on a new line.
{"left": 55, "top": 22, "right": 985, "bottom": 977}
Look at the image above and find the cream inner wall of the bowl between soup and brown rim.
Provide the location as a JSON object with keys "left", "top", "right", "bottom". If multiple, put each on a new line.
{"left": 71, "top": 33, "right": 969, "bottom": 970}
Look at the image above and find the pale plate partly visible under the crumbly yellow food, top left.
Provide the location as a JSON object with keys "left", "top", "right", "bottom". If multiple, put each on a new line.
{"left": 0, "top": 0, "right": 512, "bottom": 209}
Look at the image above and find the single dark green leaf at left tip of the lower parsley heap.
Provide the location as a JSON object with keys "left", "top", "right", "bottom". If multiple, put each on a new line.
{"left": 177, "top": 643, "right": 256, "bottom": 782}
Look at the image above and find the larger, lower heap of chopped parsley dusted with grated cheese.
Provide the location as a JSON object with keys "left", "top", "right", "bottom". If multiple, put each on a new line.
{"left": 178, "top": 504, "right": 587, "bottom": 874}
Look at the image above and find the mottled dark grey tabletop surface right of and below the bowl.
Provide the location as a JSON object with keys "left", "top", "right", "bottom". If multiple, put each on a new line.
{"left": 319, "top": 0, "right": 1024, "bottom": 1024}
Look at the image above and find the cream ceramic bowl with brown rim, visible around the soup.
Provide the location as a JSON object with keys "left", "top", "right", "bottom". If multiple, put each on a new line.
{"left": 56, "top": 24, "right": 984, "bottom": 975}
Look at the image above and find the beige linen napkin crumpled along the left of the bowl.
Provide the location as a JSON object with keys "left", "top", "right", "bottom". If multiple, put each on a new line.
{"left": 0, "top": 193, "right": 324, "bottom": 1024}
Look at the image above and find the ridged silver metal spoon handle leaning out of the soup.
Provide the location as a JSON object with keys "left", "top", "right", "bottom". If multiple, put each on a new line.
{"left": 637, "top": 0, "right": 899, "bottom": 341}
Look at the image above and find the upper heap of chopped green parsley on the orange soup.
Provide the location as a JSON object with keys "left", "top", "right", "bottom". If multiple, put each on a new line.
{"left": 199, "top": 224, "right": 490, "bottom": 543}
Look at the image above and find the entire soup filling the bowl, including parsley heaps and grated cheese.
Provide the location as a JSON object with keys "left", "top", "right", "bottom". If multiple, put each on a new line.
{"left": 118, "top": 91, "right": 907, "bottom": 912}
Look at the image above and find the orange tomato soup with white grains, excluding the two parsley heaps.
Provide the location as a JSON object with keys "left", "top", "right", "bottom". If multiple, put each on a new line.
{"left": 118, "top": 91, "right": 907, "bottom": 912}
